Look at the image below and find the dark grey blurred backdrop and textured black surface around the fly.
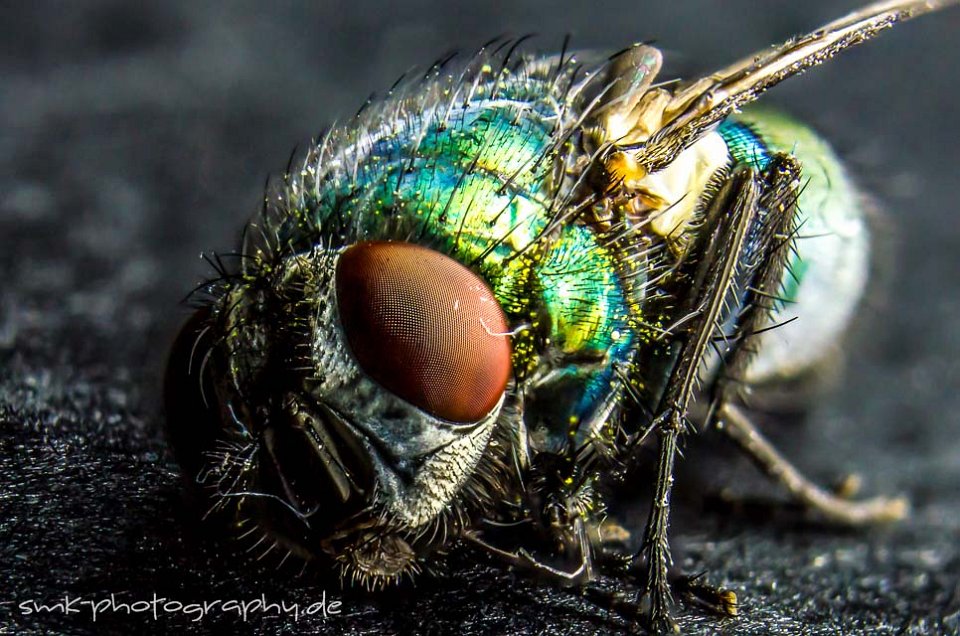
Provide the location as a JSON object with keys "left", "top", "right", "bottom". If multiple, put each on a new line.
{"left": 0, "top": 0, "right": 960, "bottom": 634}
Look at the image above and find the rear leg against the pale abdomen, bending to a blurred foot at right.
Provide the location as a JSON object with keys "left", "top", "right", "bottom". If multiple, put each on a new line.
{"left": 710, "top": 154, "right": 908, "bottom": 525}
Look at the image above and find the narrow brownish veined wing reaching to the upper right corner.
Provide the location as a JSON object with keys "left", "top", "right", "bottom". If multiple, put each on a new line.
{"left": 632, "top": 0, "right": 960, "bottom": 173}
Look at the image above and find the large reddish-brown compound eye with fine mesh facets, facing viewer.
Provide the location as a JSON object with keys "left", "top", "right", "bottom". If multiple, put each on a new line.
{"left": 337, "top": 241, "right": 511, "bottom": 422}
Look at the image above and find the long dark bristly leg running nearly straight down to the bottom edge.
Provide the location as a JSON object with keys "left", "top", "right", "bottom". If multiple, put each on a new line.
{"left": 642, "top": 168, "right": 762, "bottom": 631}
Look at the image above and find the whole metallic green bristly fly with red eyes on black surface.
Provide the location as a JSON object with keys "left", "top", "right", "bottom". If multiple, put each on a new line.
{"left": 166, "top": 0, "right": 955, "bottom": 631}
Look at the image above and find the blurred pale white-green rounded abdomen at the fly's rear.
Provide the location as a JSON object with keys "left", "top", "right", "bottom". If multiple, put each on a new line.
{"left": 717, "top": 108, "right": 870, "bottom": 384}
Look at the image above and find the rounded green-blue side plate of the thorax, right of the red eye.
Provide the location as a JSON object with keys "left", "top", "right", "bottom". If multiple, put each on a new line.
{"left": 523, "top": 226, "right": 645, "bottom": 450}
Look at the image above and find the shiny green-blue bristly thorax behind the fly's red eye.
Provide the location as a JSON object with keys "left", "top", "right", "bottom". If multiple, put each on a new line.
{"left": 281, "top": 63, "right": 635, "bottom": 432}
